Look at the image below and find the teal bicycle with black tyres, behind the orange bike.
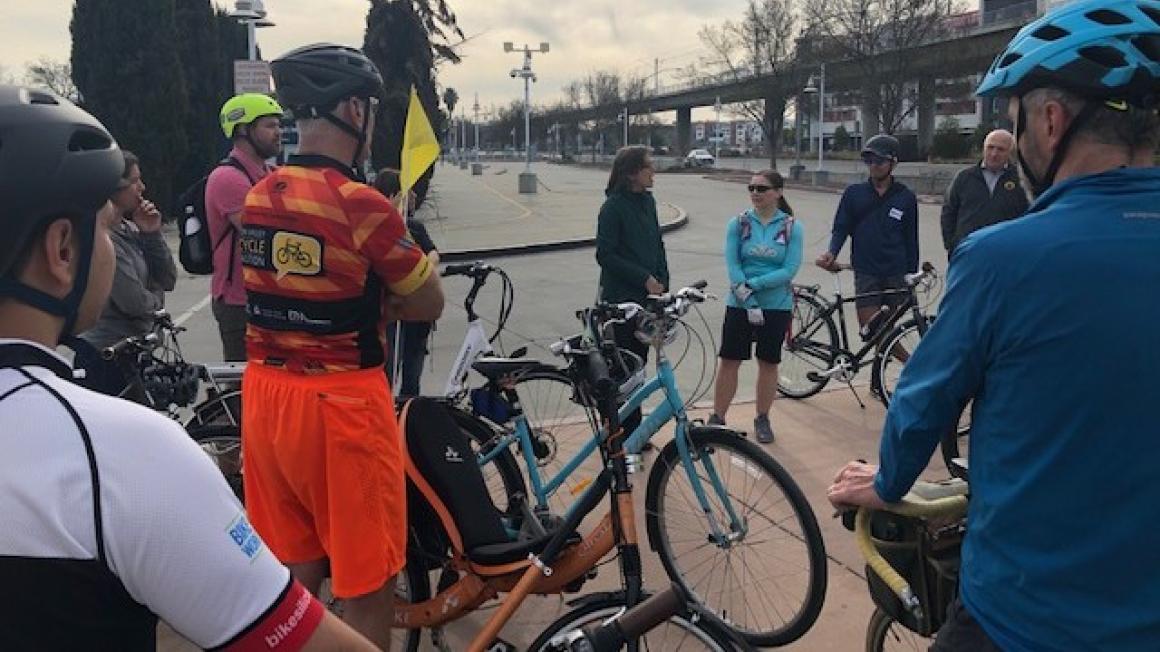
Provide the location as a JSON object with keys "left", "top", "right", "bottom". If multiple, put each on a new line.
{"left": 457, "top": 282, "right": 826, "bottom": 646}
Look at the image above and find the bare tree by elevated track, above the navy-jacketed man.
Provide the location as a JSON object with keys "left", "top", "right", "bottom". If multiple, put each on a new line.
{"left": 799, "top": 0, "right": 956, "bottom": 136}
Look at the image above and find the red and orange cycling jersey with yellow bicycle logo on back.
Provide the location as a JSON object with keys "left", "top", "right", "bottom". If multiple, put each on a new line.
{"left": 239, "top": 155, "right": 432, "bottom": 374}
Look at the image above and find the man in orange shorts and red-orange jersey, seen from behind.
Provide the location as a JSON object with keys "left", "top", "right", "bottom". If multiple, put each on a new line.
{"left": 239, "top": 44, "right": 443, "bottom": 650}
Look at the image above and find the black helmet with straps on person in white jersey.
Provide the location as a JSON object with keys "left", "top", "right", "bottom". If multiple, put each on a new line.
{"left": 0, "top": 86, "right": 125, "bottom": 335}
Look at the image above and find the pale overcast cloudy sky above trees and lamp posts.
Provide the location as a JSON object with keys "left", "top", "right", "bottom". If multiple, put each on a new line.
{"left": 0, "top": 0, "right": 746, "bottom": 116}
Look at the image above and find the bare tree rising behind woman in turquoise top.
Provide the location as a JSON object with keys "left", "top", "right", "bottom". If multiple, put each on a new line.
{"left": 698, "top": 0, "right": 800, "bottom": 169}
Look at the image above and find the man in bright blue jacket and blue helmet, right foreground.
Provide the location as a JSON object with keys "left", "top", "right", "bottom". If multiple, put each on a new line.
{"left": 829, "top": 0, "right": 1160, "bottom": 652}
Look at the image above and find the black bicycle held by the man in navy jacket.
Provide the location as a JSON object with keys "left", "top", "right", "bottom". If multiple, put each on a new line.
{"left": 777, "top": 262, "right": 938, "bottom": 407}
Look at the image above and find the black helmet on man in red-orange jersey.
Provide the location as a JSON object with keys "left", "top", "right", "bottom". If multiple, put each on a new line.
{"left": 270, "top": 43, "right": 383, "bottom": 113}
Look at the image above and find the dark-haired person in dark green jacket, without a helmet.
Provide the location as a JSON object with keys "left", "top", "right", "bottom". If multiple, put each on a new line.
{"left": 596, "top": 145, "right": 668, "bottom": 433}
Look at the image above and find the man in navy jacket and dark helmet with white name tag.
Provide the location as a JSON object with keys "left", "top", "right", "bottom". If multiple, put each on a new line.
{"left": 815, "top": 133, "right": 919, "bottom": 326}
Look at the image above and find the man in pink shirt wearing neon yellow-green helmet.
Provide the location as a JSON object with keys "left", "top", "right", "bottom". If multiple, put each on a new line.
{"left": 205, "top": 93, "right": 282, "bottom": 362}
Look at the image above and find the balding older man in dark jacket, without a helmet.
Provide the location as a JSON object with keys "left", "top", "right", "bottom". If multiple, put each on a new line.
{"left": 942, "top": 129, "right": 1027, "bottom": 258}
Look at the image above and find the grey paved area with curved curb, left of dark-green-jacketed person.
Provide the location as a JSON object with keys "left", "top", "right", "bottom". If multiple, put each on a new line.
{"left": 419, "top": 162, "right": 688, "bottom": 260}
